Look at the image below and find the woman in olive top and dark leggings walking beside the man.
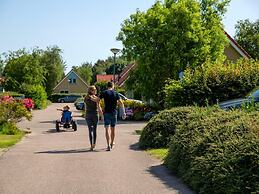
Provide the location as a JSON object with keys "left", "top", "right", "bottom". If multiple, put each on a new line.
{"left": 84, "top": 86, "right": 103, "bottom": 150}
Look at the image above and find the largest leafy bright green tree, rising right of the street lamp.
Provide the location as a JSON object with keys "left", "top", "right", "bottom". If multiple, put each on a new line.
{"left": 118, "top": 0, "right": 228, "bottom": 103}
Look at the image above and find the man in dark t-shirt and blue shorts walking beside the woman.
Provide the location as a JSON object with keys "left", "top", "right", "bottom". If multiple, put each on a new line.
{"left": 100, "top": 82, "right": 126, "bottom": 151}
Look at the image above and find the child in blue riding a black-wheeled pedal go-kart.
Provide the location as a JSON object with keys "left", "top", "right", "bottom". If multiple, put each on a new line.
{"left": 56, "top": 110, "right": 77, "bottom": 132}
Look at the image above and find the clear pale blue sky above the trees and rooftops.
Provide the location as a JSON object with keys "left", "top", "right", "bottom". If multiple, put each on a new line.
{"left": 0, "top": 0, "right": 259, "bottom": 71}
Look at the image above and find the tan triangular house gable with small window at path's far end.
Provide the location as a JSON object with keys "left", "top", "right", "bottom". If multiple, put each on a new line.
{"left": 53, "top": 70, "right": 88, "bottom": 94}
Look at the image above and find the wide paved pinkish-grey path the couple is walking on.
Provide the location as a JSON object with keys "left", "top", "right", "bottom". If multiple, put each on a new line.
{"left": 0, "top": 104, "right": 195, "bottom": 194}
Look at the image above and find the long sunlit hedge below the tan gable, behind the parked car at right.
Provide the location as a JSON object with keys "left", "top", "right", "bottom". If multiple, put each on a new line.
{"left": 164, "top": 60, "right": 259, "bottom": 107}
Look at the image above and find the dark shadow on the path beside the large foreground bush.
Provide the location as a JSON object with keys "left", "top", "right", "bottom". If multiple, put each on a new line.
{"left": 147, "top": 164, "right": 194, "bottom": 194}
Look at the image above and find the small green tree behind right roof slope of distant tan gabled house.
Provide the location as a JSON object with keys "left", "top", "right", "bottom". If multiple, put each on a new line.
{"left": 72, "top": 62, "right": 93, "bottom": 85}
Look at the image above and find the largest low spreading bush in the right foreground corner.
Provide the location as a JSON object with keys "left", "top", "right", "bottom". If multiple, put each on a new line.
{"left": 165, "top": 108, "right": 259, "bottom": 194}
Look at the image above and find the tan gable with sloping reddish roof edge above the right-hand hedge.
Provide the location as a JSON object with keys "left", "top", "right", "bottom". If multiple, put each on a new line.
{"left": 224, "top": 32, "right": 251, "bottom": 62}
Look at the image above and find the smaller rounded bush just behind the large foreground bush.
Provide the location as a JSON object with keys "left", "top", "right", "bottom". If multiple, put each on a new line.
{"left": 139, "top": 107, "right": 192, "bottom": 148}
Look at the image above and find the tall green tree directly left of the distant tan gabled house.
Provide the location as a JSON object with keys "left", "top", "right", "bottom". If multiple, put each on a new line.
{"left": 40, "top": 46, "right": 65, "bottom": 95}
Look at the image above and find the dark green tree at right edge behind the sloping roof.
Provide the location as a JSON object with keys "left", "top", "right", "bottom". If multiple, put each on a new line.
{"left": 235, "top": 19, "right": 259, "bottom": 59}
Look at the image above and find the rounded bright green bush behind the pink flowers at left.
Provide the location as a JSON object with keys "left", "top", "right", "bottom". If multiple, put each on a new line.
{"left": 22, "top": 84, "right": 47, "bottom": 109}
